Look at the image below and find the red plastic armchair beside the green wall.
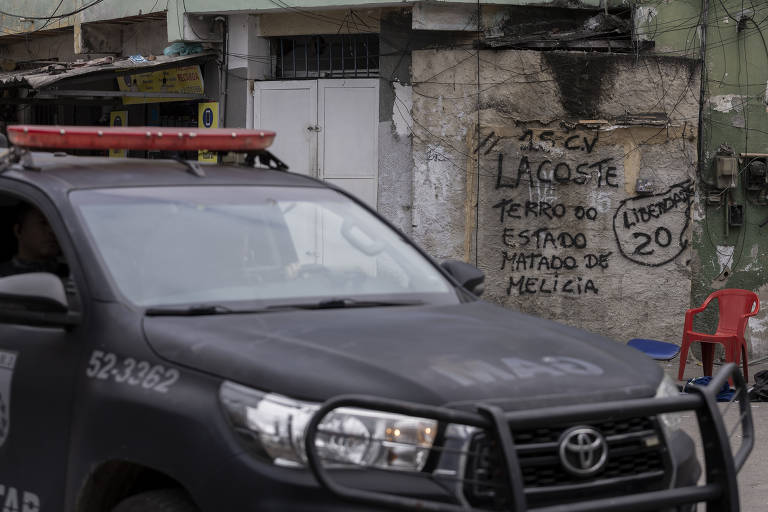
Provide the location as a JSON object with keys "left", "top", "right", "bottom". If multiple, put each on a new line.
{"left": 677, "top": 289, "right": 760, "bottom": 382}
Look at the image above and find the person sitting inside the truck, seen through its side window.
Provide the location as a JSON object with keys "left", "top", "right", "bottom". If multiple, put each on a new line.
{"left": 0, "top": 202, "right": 69, "bottom": 277}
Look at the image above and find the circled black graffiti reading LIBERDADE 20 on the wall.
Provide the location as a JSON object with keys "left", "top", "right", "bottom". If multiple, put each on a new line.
{"left": 613, "top": 179, "right": 694, "bottom": 267}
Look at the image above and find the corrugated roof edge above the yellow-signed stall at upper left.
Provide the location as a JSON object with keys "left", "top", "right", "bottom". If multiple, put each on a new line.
{"left": 0, "top": 52, "right": 216, "bottom": 89}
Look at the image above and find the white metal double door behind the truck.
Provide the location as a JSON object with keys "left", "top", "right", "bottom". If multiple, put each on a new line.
{"left": 252, "top": 79, "right": 379, "bottom": 208}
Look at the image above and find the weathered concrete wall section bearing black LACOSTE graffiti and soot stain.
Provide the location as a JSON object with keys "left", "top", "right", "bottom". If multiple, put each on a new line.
{"left": 413, "top": 50, "right": 699, "bottom": 341}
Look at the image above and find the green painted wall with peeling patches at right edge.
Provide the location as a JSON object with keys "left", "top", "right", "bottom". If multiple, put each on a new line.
{"left": 645, "top": 0, "right": 768, "bottom": 357}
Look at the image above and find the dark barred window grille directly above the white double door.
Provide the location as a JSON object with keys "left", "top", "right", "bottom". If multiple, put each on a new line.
{"left": 269, "top": 34, "right": 379, "bottom": 80}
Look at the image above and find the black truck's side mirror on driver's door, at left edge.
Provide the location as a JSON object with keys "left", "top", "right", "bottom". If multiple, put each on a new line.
{"left": 0, "top": 272, "right": 75, "bottom": 327}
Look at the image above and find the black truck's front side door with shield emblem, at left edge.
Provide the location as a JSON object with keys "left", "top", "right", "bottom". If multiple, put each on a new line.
{"left": 0, "top": 189, "right": 84, "bottom": 512}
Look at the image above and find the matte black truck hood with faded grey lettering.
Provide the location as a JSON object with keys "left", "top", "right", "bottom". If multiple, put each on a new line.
{"left": 144, "top": 301, "right": 663, "bottom": 410}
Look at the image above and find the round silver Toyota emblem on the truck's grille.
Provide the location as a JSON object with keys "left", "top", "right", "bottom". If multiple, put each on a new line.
{"left": 559, "top": 426, "right": 608, "bottom": 476}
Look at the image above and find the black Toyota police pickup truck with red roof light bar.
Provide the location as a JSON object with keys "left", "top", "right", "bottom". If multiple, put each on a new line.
{"left": 0, "top": 126, "right": 752, "bottom": 512}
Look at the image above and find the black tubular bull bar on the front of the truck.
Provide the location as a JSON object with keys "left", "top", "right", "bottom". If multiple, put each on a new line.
{"left": 305, "top": 363, "right": 754, "bottom": 512}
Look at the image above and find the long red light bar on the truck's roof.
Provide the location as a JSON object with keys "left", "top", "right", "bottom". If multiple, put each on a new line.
{"left": 8, "top": 125, "right": 275, "bottom": 153}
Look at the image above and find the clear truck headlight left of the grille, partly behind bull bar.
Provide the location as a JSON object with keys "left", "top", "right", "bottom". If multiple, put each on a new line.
{"left": 219, "top": 382, "right": 438, "bottom": 471}
